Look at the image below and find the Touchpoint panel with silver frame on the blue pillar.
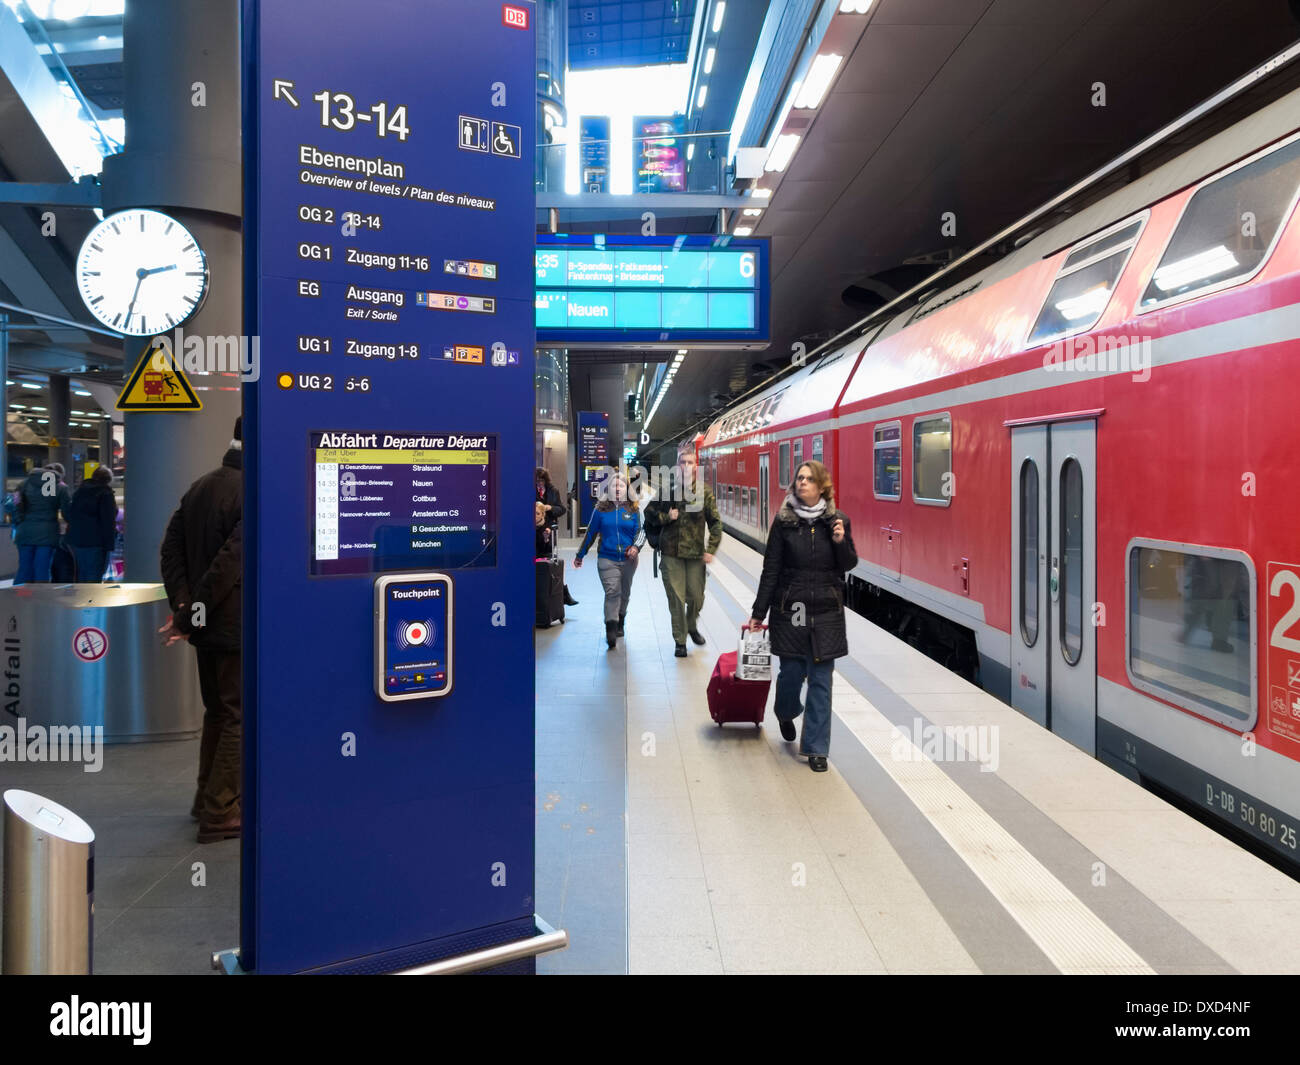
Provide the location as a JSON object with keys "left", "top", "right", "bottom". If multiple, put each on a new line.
{"left": 374, "top": 573, "right": 452, "bottom": 702}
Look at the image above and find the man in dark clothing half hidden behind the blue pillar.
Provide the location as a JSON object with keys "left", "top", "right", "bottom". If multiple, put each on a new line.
{"left": 161, "top": 417, "right": 243, "bottom": 843}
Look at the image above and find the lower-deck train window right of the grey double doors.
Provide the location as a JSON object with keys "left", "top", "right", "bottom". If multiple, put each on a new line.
{"left": 1127, "top": 540, "right": 1256, "bottom": 732}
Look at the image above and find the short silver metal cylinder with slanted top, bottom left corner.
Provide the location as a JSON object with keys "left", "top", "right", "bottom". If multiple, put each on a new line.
{"left": 0, "top": 788, "right": 95, "bottom": 977}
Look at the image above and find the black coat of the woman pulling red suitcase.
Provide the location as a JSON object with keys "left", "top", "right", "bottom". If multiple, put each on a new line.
{"left": 750, "top": 501, "right": 858, "bottom": 662}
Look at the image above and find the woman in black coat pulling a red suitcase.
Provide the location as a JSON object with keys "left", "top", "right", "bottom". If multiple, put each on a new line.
{"left": 750, "top": 462, "right": 858, "bottom": 772}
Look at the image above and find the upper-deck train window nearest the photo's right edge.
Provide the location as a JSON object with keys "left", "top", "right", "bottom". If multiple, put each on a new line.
{"left": 1138, "top": 137, "right": 1300, "bottom": 311}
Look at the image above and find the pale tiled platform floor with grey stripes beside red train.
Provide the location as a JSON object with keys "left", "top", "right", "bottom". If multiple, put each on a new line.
{"left": 537, "top": 540, "right": 1300, "bottom": 974}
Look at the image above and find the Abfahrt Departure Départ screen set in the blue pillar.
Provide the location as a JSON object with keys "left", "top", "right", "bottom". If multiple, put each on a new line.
{"left": 309, "top": 430, "right": 497, "bottom": 576}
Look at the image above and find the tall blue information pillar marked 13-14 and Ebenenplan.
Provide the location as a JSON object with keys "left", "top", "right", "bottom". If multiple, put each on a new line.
{"left": 241, "top": 0, "right": 536, "bottom": 973}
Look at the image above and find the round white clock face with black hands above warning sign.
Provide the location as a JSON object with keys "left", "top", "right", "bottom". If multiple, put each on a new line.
{"left": 77, "top": 208, "right": 208, "bottom": 337}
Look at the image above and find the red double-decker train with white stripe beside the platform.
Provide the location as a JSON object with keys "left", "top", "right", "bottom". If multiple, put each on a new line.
{"left": 699, "top": 92, "right": 1300, "bottom": 863}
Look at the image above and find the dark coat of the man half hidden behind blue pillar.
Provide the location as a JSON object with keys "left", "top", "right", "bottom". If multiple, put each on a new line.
{"left": 161, "top": 447, "right": 243, "bottom": 651}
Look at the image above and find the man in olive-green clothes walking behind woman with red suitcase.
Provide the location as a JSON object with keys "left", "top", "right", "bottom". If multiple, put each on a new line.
{"left": 645, "top": 447, "right": 723, "bottom": 658}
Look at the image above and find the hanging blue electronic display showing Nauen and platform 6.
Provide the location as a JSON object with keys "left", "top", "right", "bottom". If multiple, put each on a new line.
{"left": 534, "top": 235, "right": 770, "bottom": 345}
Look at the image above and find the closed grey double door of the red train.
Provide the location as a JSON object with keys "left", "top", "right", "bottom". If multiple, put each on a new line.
{"left": 1011, "top": 420, "right": 1097, "bottom": 754}
